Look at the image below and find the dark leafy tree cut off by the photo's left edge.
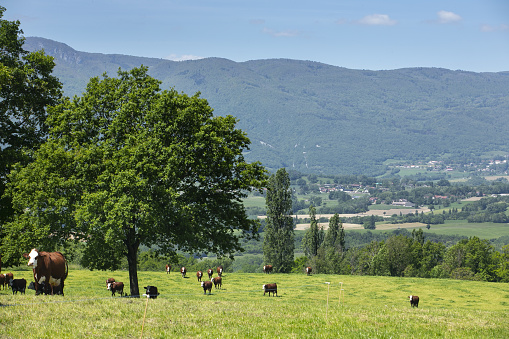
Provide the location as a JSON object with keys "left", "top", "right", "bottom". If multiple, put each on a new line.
{"left": 0, "top": 6, "right": 62, "bottom": 225}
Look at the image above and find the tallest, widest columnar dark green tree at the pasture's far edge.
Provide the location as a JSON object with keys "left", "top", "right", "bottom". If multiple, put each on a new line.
{"left": 263, "top": 168, "right": 295, "bottom": 273}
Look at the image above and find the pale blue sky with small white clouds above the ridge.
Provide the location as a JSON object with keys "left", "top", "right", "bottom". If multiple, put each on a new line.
{"left": 2, "top": 0, "right": 509, "bottom": 72}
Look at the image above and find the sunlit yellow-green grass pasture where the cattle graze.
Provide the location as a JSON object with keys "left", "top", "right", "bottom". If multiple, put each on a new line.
{"left": 0, "top": 269, "right": 509, "bottom": 338}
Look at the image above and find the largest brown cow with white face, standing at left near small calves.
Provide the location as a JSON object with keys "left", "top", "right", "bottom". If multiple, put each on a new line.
{"left": 23, "top": 248, "right": 69, "bottom": 295}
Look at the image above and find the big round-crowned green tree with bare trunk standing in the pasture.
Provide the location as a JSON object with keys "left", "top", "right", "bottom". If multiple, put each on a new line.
{"left": 2, "top": 66, "right": 266, "bottom": 296}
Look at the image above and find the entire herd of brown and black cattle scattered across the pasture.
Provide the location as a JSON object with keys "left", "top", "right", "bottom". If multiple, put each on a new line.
{"left": 0, "top": 248, "right": 419, "bottom": 307}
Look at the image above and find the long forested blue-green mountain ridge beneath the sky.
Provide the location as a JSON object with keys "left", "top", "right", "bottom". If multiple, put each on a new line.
{"left": 24, "top": 37, "right": 509, "bottom": 175}
